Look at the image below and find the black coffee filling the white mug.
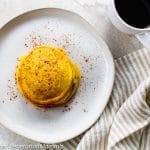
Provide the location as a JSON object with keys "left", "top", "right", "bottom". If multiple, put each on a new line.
{"left": 115, "top": 0, "right": 150, "bottom": 28}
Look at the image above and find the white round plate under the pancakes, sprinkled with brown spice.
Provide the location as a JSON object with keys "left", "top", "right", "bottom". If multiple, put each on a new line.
{"left": 0, "top": 8, "right": 114, "bottom": 143}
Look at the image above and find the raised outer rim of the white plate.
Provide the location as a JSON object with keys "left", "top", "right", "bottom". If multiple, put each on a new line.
{"left": 0, "top": 7, "right": 115, "bottom": 144}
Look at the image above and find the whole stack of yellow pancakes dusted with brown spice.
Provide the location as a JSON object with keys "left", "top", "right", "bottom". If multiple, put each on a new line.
{"left": 16, "top": 46, "right": 80, "bottom": 107}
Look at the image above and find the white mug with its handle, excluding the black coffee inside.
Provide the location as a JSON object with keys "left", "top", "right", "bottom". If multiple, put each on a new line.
{"left": 108, "top": 0, "right": 150, "bottom": 48}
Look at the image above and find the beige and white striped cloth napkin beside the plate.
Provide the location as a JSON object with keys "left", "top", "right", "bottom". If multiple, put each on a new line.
{"left": 64, "top": 49, "right": 150, "bottom": 150}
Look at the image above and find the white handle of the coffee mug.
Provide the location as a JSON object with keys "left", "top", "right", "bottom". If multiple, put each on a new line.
{"left": 135, "top": 32, "right": 150, "bottom": 48}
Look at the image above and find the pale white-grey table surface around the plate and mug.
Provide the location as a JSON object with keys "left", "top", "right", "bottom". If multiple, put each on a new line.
{"left": 0, "top": 0, "right": 142, "bottom": 148}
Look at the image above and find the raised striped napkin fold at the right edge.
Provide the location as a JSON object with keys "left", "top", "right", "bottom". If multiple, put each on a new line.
{"left": 108, "top": 78, "right": 150, "bottom": 149}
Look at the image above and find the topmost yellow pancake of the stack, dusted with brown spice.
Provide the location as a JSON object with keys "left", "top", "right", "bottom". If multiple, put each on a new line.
{"left": 17, "top": 46, "right": 73, "bottom": 100}
